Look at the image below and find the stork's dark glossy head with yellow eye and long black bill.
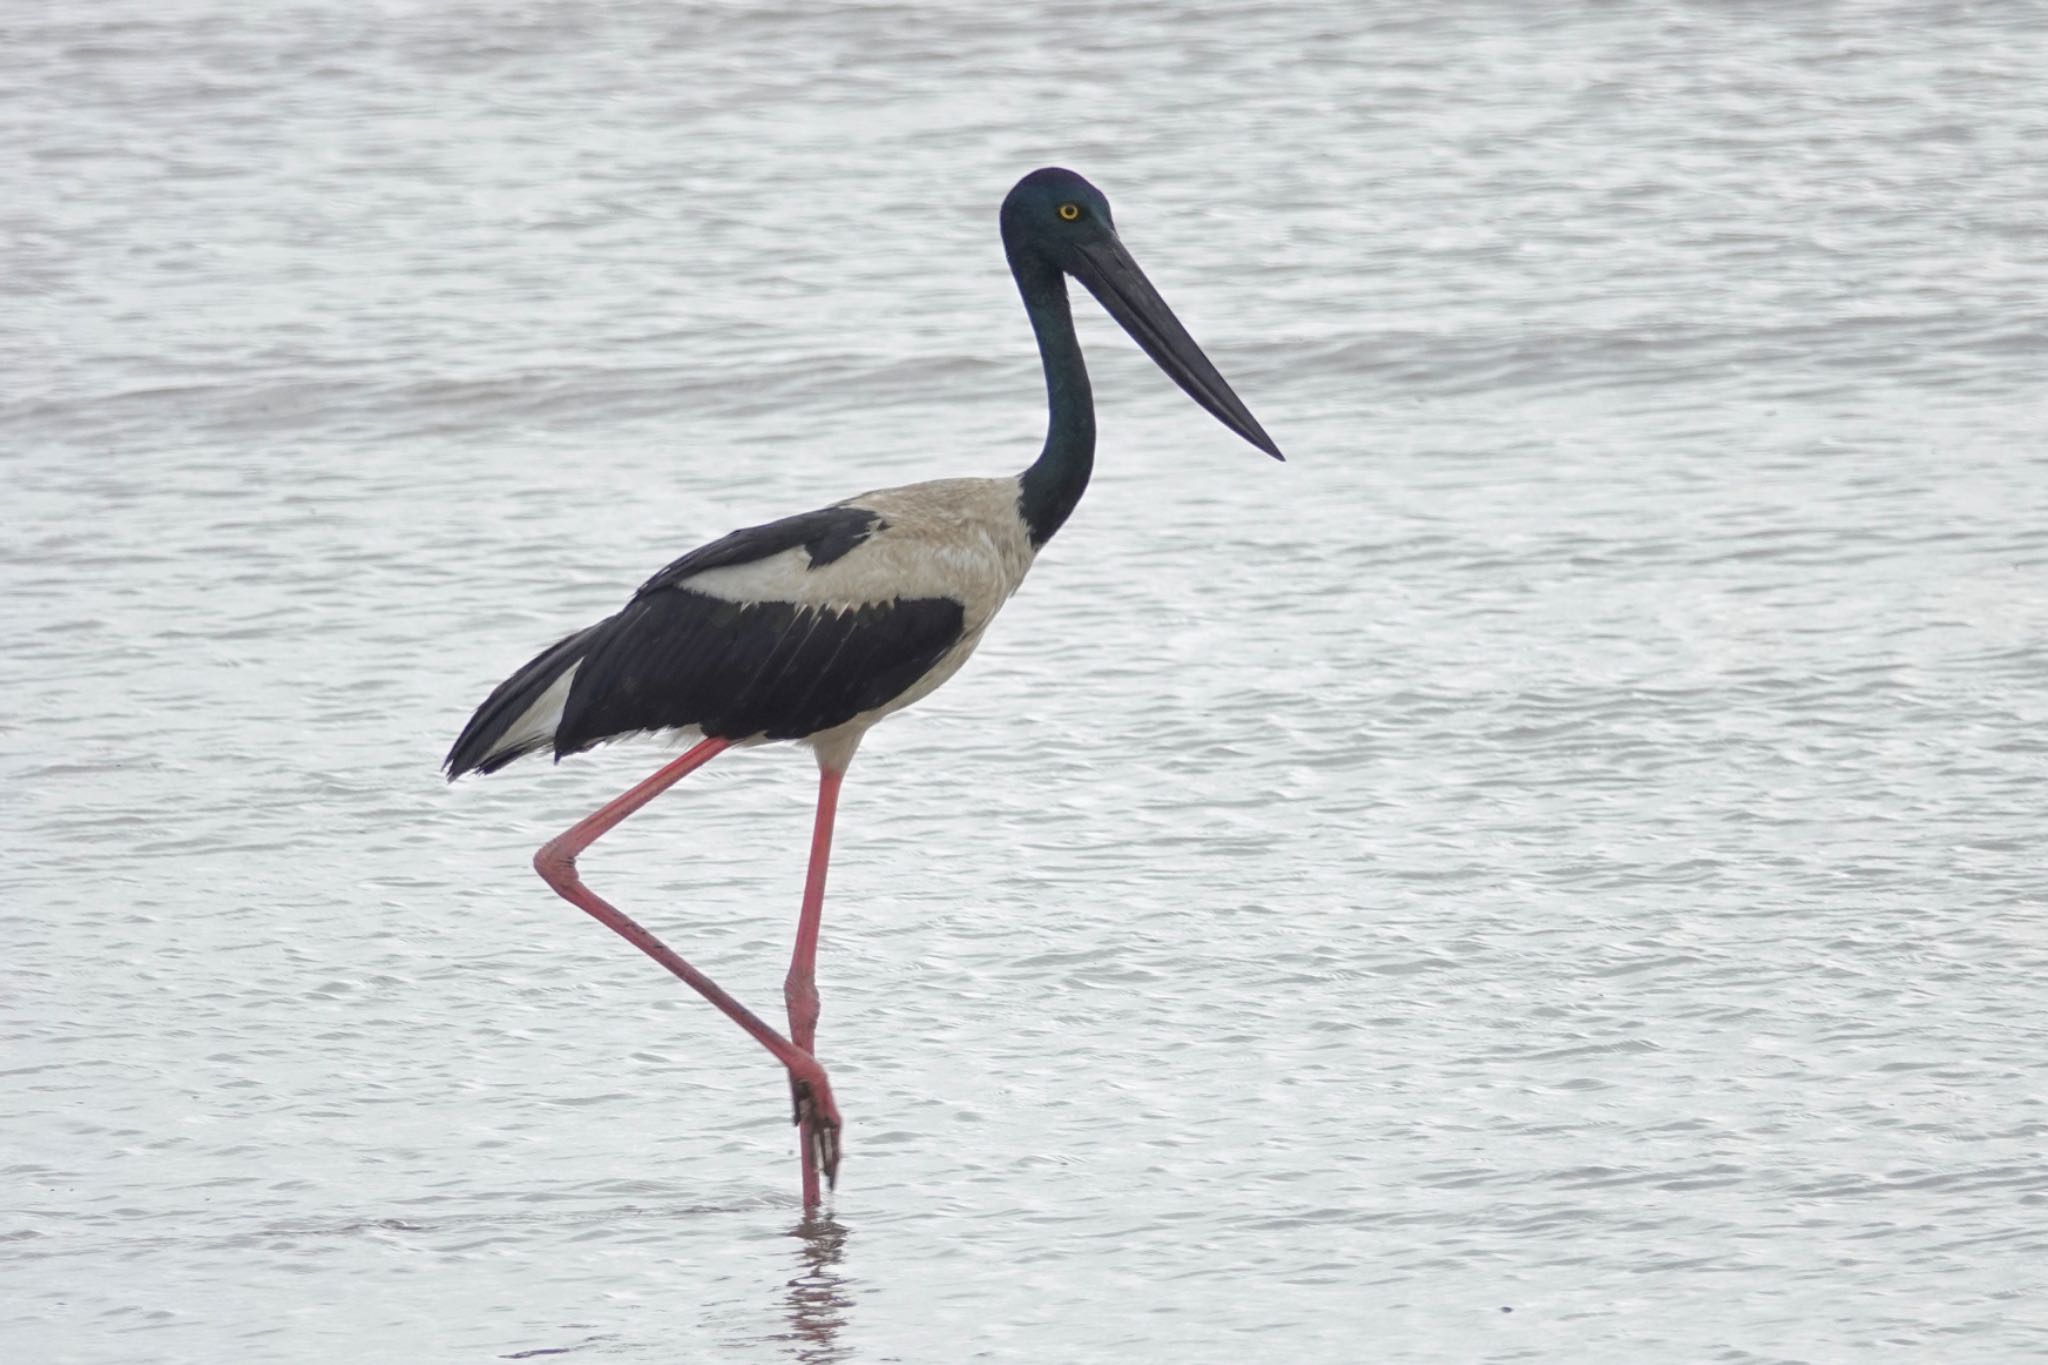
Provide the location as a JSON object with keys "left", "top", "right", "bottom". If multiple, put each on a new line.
{"left": 1001, "top": 166, "right": 1284, "bottom": 460}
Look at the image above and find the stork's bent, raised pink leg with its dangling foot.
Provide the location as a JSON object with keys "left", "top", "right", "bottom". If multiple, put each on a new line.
{"left": 532, "top": 739, "right": 840, "bottom": 1201}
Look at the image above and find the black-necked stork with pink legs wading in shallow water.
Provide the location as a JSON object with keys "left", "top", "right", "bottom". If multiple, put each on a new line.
{"left": 444, "top": 168, "right": 1280, "bottom": 1209}
